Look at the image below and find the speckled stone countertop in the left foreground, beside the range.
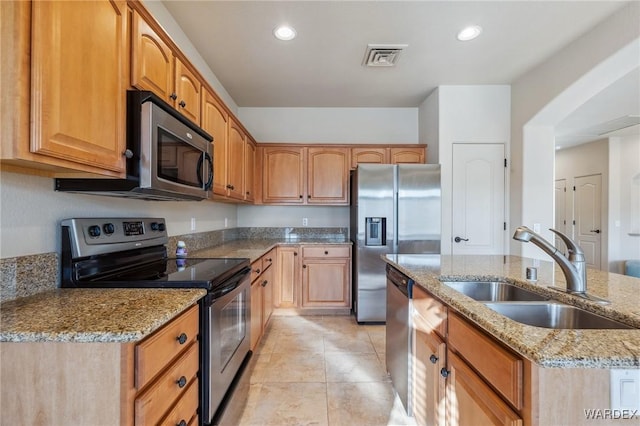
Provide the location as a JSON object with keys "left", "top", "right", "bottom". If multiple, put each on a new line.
{"left": 0, "top": 288, "right": 206, "bottom": 343}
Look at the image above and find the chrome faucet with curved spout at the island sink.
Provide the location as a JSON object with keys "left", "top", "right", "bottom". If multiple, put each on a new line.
{"left": 513, "top": 226, "right": 609, "bottom": 304}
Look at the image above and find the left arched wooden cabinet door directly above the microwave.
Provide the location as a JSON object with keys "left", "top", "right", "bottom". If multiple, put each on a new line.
{"left": 131, "top": 11, "right": 174, "bottom": 104}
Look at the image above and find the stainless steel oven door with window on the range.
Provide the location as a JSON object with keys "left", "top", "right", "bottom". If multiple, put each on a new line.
{"left": 202, "top": 269, "right": 251, "bottom": 424}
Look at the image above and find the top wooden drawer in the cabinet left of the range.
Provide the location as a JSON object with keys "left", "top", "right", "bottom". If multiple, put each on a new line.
{"left": 135, "top": 305, "right": 198, "bottom": 389}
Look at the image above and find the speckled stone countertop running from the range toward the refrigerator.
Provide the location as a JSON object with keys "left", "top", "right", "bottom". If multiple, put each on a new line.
{"left": 189, "top": 238, "right": 351, "bottom": 262}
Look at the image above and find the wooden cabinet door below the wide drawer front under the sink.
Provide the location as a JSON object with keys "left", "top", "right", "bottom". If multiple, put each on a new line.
{"left": 447, "top": 350, "right": 523, "bottom": 426}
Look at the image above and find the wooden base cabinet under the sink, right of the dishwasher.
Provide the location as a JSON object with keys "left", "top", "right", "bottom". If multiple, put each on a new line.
{"left": 412, "top": 286, "right": 533, "bottom": 426}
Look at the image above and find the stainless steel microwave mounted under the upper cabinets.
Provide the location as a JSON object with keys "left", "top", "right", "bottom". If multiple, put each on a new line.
{"left": 55, "top": 90, "right": 214, "bottom": 200}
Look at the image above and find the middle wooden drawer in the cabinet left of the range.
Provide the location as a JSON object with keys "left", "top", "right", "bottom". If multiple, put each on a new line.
{"left": 135, "top": 343, "right": 198, "bottom": 425}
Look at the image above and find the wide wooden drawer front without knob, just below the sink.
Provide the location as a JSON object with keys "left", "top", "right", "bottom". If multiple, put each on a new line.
{"left": 449, "top": 314, "right": 523, "bottom": 410}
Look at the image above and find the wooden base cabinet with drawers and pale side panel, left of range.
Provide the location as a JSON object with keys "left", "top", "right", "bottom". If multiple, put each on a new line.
{"left": 0, "top": 306, "right": 199, "bottom": 425}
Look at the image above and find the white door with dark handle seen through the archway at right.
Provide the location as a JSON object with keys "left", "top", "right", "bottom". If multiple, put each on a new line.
{"left": 573, "top": 174, "right": 602, "bottom": 269}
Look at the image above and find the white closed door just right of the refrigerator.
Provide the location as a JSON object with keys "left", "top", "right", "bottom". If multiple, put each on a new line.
{"left": 451, "top": 143, "right": 506, "bottom": 254}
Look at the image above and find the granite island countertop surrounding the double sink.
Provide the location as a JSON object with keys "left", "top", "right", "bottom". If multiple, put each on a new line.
{"left": 383, "top": 254, "right": 640, "bottom": 368}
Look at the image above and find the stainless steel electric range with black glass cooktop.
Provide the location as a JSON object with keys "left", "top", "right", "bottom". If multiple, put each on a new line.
{"left": 61, "top": 218, "right": 251, "bottom": 425}
